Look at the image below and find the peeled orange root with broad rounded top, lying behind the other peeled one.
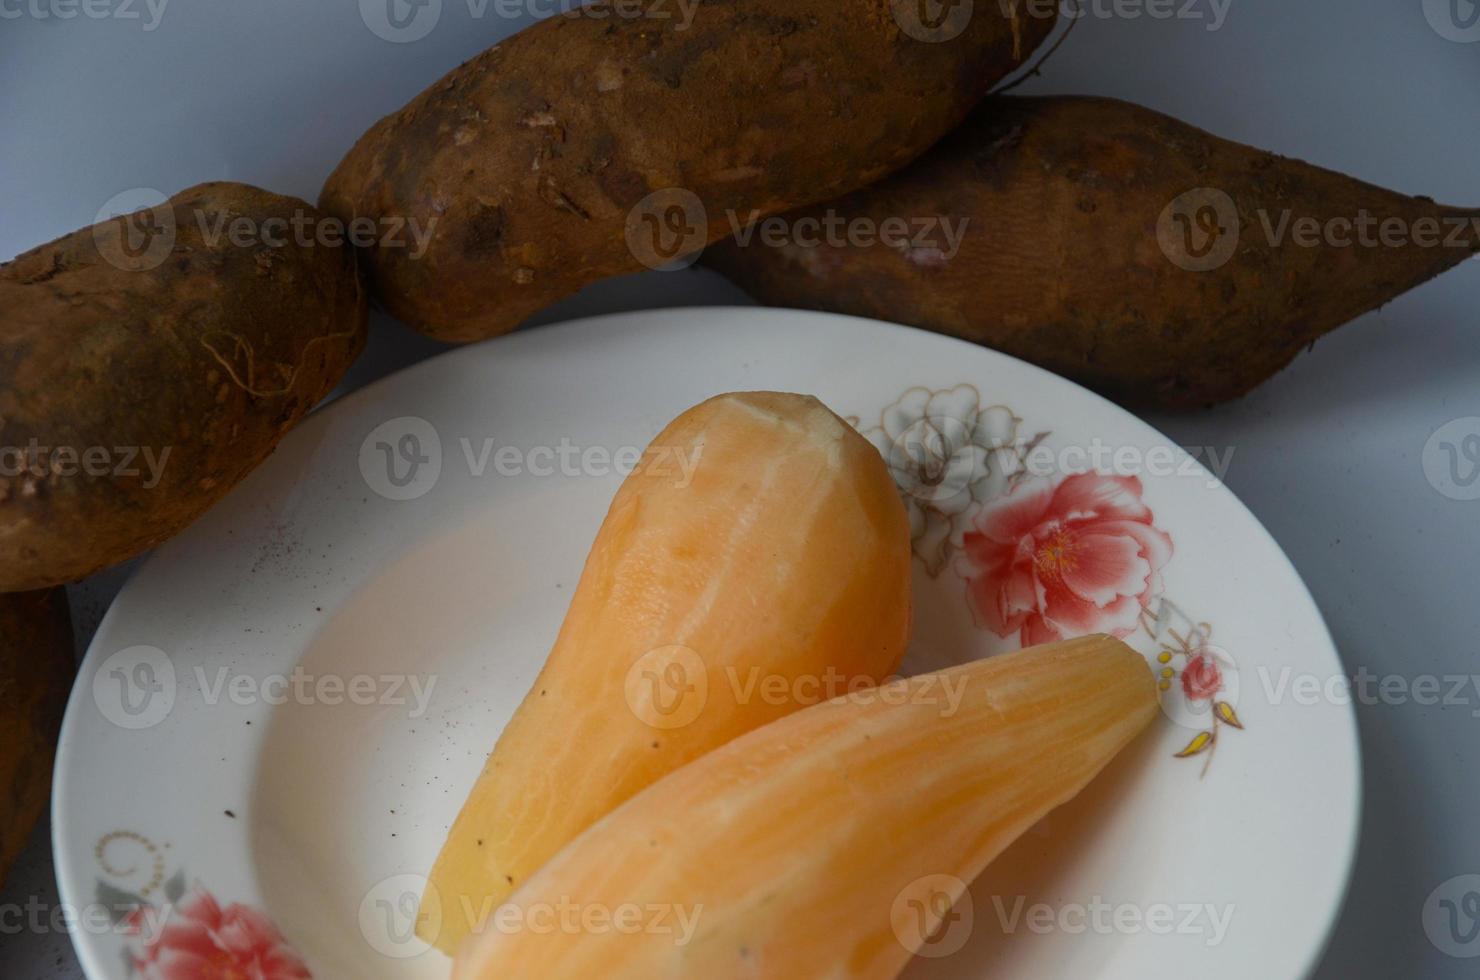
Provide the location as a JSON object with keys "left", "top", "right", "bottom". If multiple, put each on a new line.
{"left": 417, "top": 392, "right": 910, "bottom": 953}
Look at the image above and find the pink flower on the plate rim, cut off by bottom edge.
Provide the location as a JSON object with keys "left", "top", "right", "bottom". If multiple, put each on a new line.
{"left": 133, "top": 885, "right": 312, "bottom": 980}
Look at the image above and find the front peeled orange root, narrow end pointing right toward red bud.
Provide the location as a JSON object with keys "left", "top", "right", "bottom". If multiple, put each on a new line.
{"left": 453, "top": 637, "right": 1157, "bottom": 980}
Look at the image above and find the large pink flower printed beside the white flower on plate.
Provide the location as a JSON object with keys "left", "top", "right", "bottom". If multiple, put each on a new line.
{"left": 959, "top": 474, "right": 1172, "bottom": 647}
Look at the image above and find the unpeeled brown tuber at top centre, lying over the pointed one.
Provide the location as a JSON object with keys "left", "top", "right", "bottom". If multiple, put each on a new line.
{"left": 320, "top": 0, "right": 1055, "bottom": 342}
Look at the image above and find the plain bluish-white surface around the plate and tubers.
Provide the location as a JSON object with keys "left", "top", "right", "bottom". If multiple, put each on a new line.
{"left": 0, "top": 0, "right": 1480, "bottom": 980}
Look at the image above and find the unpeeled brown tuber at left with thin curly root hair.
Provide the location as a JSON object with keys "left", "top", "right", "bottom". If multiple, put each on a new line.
{"left": 0, "top": 184, "right": 366, "bottom": 592}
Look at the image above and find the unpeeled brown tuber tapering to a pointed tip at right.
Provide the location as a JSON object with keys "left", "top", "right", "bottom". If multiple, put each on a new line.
{"left": 704, "top": 98, "right": 1480, "bottom": 409}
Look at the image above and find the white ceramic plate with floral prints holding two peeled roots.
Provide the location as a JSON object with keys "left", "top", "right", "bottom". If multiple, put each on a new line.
{"left": 55, "top": 309, "right": 1360, "bottom": 980}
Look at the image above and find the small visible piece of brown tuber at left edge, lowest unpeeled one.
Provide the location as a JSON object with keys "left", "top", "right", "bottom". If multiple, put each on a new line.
{"left": 0, "top": 589, "right": 77, "bottom": 882}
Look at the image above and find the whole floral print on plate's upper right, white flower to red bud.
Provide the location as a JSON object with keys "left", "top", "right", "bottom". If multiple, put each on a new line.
{"left": 858, "top": 383, "right": 1243, "bottom": 774}
